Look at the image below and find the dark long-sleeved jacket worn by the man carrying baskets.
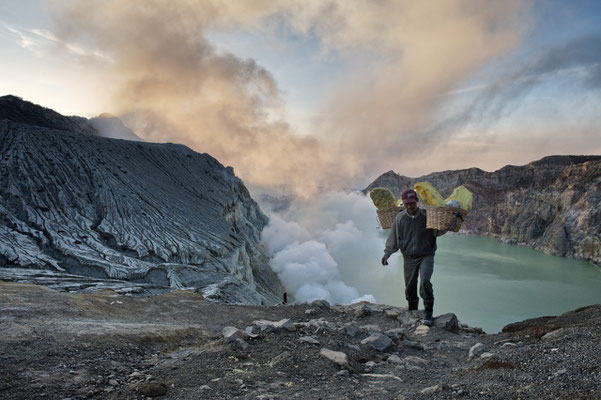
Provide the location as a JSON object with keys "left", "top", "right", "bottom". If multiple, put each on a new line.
{"left": 384, "top": 208, "right": 436, "bottom": 258}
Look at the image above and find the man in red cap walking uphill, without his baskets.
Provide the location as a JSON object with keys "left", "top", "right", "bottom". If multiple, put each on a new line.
{"left": 382, "top": 189, "right": 446, "bottom": 326}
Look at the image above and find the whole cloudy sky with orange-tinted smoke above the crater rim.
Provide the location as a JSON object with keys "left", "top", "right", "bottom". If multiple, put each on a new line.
{"left": 0, "top": 0, "right": 601, "bottom": 195}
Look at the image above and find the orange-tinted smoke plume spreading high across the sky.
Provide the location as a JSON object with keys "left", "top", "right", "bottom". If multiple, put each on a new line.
{"left": 50, "top": 0, "right": 527, "bottom": 193}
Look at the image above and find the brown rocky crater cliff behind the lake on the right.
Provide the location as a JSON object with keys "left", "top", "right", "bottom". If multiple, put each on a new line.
{"left": 364, "top": 156, "right": 601, "bottom": 265}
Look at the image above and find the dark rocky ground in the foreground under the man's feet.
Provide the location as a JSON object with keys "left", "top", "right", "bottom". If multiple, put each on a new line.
{"left": 0, "top": 281, "right": 601, "bottom": 399}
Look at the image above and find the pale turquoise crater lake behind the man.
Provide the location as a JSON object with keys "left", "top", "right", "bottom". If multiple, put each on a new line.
{"left": 366, "top": 234, "right": 601, "bottom": 333}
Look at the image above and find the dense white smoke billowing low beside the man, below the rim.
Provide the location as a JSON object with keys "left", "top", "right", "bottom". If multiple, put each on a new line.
{"left": 263, "top": 192, "right": 402, "bottom": 304}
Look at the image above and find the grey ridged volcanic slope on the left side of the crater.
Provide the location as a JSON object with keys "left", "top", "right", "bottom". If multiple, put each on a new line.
{"left": 0, "top": 96, "right": 283, "bottom": 304}
